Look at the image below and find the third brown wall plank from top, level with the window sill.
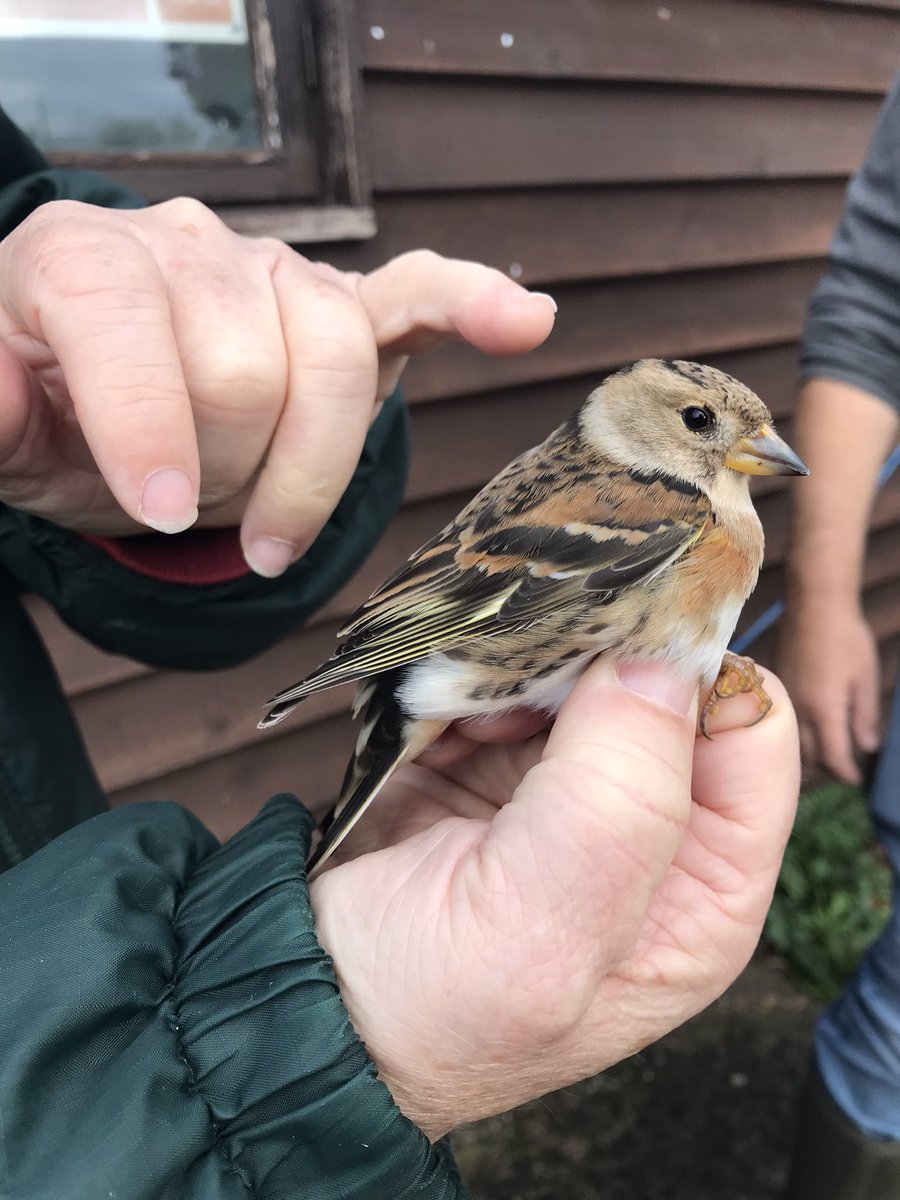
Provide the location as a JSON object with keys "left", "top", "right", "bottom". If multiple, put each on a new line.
{"left": 321, "top": 179, "right": 845, "bottom": 287}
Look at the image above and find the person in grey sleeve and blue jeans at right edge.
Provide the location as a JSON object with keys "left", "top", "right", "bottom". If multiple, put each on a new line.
{"left": 780, "top": 80, "right": 900, "bottom": 1200}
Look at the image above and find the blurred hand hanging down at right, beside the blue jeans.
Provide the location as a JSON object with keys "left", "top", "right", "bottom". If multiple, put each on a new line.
{"left": 779, "top": 600, "right": 881, "bottom": 784}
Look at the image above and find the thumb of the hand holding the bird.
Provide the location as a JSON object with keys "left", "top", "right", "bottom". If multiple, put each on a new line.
{"left": 482, "top": 659, "right": 697, "bottom": 970}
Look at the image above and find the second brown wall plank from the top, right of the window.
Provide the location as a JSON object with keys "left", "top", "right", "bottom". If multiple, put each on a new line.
{"left": 366, "top": 76, "right": 878, "bottom": 192}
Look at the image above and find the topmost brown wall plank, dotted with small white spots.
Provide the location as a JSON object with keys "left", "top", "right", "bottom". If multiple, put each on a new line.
{"left": 359, "top": 0, "right": 900, "bottom": 92}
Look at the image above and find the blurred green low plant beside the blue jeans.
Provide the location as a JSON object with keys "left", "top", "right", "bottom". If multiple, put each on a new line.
{"left": 766, "top": 784, "right": 890, "bottom": 1001}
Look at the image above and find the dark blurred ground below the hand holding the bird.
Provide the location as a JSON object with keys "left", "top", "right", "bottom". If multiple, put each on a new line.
{"left": 454, "top": 958, "right": 816, "bottom": 1200}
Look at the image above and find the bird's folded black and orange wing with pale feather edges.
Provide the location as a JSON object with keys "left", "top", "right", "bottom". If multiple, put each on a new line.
{"left": 260, "top": 458, "right": 710, "bottom": 726}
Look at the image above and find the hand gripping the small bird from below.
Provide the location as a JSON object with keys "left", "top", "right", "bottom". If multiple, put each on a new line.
{"left": 311, "top": 660, "right": 799, "bottom": 1139}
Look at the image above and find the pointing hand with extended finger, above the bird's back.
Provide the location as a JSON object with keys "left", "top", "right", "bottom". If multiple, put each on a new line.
{"left": 0, "top": 199, "right": 554, "bottom": 575}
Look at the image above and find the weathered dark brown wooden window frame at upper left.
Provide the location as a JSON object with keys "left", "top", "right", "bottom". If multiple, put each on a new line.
{"left": 39, "top": 0, "right": 376, "bottom": 241}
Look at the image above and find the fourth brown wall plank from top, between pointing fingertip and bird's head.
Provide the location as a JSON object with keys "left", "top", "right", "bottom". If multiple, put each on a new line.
{"left": 404, "top": 262, "right": 822, "bottom": 403}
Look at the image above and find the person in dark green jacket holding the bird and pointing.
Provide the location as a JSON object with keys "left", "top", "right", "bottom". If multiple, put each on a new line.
{"left": 0, "top": 108, "right": 799, "bottom": 1200}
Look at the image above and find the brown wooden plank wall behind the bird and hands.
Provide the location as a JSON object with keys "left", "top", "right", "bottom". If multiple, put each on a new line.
{"left": 26, "top": 0, "right": 900, "bottom": 833}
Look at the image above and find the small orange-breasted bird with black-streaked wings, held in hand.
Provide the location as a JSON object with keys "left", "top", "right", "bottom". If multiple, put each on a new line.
{"left": 259, "top": 359, "right": 809, "bottom": 877}
